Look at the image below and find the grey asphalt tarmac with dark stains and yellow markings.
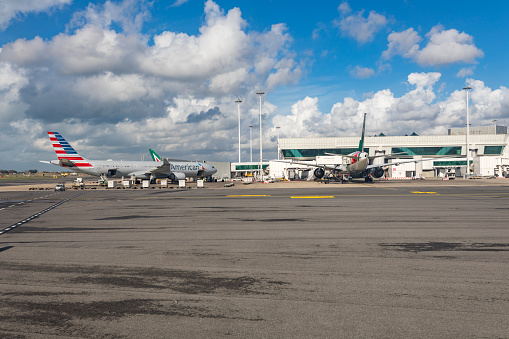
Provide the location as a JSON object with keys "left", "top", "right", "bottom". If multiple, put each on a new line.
{"left": 0, "top": 179, "right": 509, "bottom": 338}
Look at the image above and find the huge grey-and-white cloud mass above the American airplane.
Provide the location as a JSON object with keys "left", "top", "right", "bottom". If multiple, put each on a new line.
{"left": 0, "top": 0, "right": 306, "bottom": 128}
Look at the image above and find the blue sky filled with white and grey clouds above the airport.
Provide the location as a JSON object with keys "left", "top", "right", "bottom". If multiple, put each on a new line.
{"left": 0, "top": 0, "right": 509, "bottom": 171}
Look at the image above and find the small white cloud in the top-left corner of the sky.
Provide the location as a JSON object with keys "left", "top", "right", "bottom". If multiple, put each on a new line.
{"left": 0, "top": 0, "right": 72, "bottom": 30}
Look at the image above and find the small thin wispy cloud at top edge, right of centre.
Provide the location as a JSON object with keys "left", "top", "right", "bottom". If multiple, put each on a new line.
{"left": 335, "top": 2, "right": 388, "bottom": 44}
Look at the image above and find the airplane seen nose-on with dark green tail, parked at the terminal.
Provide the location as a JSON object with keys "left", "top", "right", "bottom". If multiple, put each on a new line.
{"left": 280, "top": 113, "right": 450, "bottom": 182}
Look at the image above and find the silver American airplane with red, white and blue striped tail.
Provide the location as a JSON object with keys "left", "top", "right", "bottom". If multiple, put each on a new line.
{"left": 40, "top": 132, "right": 217, "bottom": 181}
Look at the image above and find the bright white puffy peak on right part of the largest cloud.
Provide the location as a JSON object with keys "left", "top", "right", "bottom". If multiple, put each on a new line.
{"left": 138, "top": 1, "right": 252, "bottom": 80}
